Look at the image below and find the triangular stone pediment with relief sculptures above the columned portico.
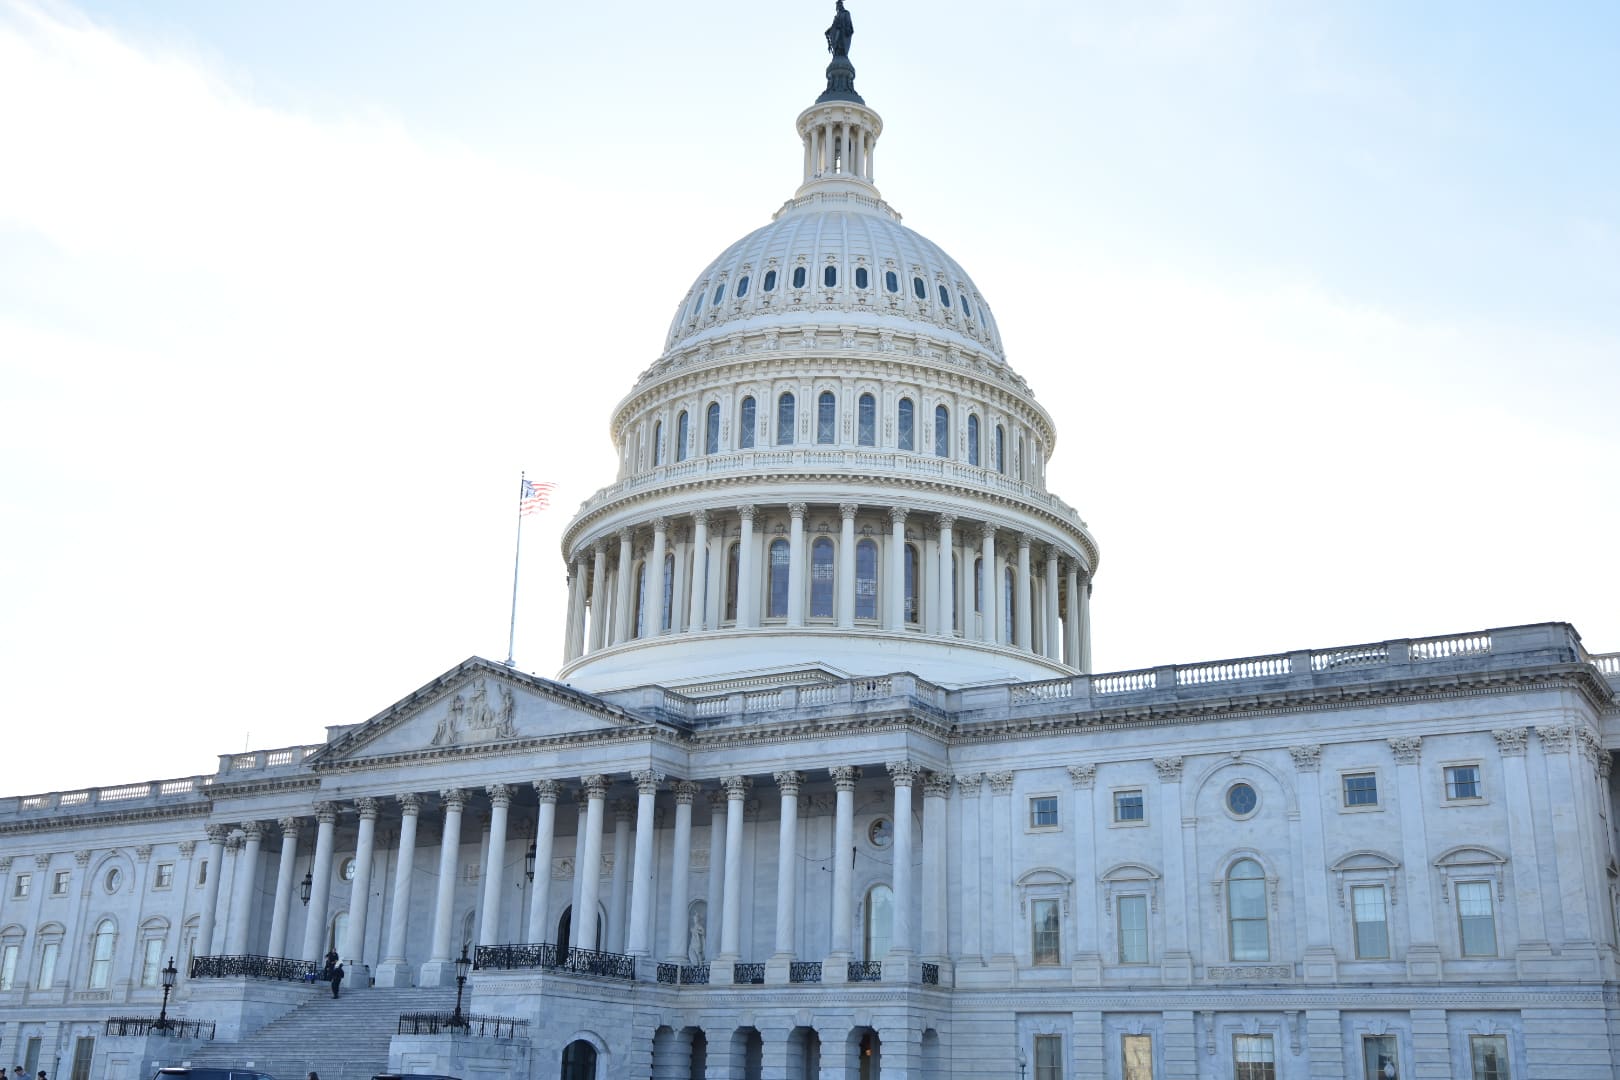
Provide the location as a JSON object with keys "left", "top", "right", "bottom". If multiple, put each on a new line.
{"left": 309, "top": 656, "right": 656, "bottom": 769}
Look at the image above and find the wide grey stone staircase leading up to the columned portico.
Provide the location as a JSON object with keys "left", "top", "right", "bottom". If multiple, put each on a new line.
{"left": 188, "top": 984, "right": 465, "bottom": 1080}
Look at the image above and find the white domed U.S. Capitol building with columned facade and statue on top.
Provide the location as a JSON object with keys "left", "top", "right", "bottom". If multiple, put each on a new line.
{"left": 0, "top": 8, "right": 1620, "bottom": 1080}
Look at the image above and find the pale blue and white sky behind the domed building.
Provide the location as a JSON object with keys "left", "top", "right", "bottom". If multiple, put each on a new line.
{"left": 0, "top": 0, "right": 1620, "bottom": 793}
